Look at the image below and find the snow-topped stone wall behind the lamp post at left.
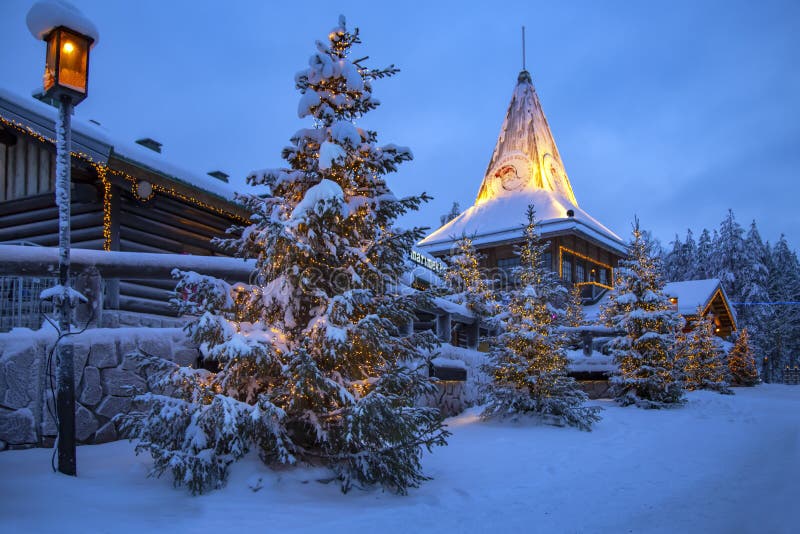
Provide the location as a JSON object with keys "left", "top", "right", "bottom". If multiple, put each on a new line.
{"left": 0, "top": 328, "right": 199, "bottom": 450}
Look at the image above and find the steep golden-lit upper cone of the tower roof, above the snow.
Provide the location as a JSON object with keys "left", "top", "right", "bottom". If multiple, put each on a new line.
{"left": 475, "top": 70, "right": 578, "bottom": 207}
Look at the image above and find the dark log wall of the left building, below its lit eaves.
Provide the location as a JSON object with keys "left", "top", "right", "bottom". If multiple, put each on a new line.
{"left": 0, "top": 129, "right": 242, "bottom": 316}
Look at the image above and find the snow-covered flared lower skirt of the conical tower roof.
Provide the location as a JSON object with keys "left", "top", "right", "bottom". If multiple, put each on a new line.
{"left": 417, "top": 190, "right": 626, "bottom": 254}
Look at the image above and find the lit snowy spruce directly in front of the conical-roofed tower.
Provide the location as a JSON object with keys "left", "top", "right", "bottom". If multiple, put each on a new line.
{"left": 483, "top": 206, "right": 600, "bottom": 430}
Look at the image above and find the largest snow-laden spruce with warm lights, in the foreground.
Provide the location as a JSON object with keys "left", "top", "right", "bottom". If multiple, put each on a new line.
{"left": 117, "top": 18, "right": 448, "bottom": 493}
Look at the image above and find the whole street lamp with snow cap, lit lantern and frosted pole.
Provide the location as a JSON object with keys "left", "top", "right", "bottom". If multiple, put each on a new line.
{"left": 26, "top": 1, "right": 98, "bottom": 476}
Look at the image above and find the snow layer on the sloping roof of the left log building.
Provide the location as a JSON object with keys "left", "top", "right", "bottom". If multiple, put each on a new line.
{"left": 0, "top": 88, "right": 236, "bottom": 201}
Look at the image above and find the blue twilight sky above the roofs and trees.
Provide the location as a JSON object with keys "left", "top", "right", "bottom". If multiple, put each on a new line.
{"left": 0, "top": 0, "right": 800, "bottom": 248}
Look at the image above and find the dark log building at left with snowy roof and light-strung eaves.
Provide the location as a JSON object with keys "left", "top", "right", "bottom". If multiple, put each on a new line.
{"left": 0, "top": 90, "right": 247, "bottom": 313}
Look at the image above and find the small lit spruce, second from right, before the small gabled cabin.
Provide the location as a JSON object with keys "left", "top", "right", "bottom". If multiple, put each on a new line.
{"left": 678, "top": 316, "right": 732, "bottom": 393}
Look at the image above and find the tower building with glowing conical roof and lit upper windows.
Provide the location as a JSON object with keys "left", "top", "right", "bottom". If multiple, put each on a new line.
{"left": 418, "top": 70, "right": 626, "bottom": 302}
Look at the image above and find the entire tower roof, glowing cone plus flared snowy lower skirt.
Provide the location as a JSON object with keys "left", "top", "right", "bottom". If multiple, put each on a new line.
{"left": 418, "top": 70, "right": 625, "bottom": 254}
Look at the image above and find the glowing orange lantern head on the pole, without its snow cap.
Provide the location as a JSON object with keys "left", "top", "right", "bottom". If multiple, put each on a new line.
{"left": 43, "top": 27, "right": 92, "bottom": 100}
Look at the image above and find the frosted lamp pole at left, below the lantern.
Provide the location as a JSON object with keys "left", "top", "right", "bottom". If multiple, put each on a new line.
{"left": 56, "top": 96, "right": 76, "bottom": 476}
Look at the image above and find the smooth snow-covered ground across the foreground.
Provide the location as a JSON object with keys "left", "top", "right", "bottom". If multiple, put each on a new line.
{"left": 0, "top": 385, "right": 800, "bottom": 534}
